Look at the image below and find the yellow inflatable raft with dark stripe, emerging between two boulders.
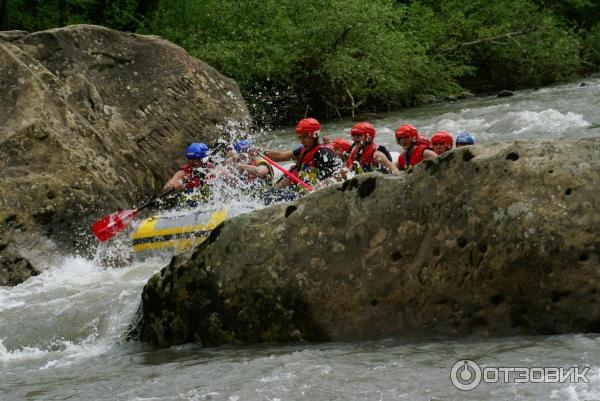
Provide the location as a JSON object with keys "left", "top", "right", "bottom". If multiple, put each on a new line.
{"left": 131, "top": 209, "right": 227, "bottom": 254}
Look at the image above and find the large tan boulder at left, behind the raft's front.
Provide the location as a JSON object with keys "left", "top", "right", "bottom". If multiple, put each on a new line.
{"left": 0, "top": 25, "right": 248, "bottom": 256}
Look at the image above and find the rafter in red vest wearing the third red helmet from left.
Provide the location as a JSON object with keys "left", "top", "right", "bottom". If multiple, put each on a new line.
{"left": 346, "top": 122, "right": 400, "bottom": 175}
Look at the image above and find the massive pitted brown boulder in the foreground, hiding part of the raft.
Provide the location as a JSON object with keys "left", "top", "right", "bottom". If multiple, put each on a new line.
{"left": 135, "top": 140, "right": 600, "bottom": 345}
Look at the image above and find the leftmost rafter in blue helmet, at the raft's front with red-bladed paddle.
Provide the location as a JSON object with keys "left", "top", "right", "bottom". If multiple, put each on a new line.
{"left": 163, "top": 143, "right": 215, "bottom": 207}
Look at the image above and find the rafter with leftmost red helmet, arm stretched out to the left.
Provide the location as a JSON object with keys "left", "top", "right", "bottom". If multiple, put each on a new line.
{"left": 264, "top": 118, "right": 341, "bottom": 190}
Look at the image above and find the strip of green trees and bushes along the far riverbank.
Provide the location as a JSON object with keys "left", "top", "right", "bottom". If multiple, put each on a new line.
{"left": 0, "top": 0, "right": 600, "bottom": 123}
